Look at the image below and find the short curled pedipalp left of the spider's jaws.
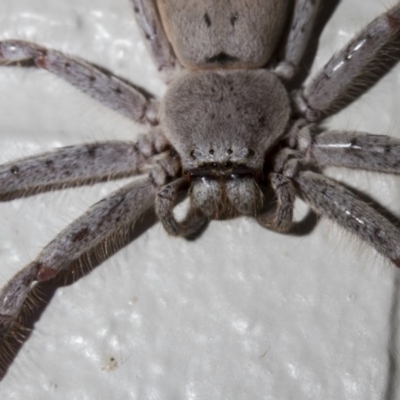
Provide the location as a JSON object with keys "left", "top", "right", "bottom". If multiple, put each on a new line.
{"left": 155, "top": 176, "right": 208, "bottom": 238}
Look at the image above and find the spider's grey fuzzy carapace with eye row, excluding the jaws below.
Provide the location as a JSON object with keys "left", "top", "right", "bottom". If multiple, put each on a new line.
{"left": 160, "top": 69, "right": 290, "bottom": 170}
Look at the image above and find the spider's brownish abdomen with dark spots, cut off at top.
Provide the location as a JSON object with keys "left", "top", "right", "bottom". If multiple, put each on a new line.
{"left": 157, "top": 0, "right": 289, "bottom": 69}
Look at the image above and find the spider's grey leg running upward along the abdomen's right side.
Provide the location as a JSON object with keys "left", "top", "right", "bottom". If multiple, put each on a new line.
{"left": 275, "top": 0, "right": 321, "bottom": 81}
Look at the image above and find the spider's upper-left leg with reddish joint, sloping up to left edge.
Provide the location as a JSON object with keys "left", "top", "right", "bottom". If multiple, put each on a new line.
{"left": 0, "top": 40, "right": 158, "bottom": 124}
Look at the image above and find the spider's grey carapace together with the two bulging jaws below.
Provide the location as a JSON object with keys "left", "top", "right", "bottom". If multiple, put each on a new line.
{"left": 161, "top": 70, "right": 290, "bottom": 222}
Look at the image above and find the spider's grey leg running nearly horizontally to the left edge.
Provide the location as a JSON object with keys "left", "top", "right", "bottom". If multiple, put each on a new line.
{"left": 0, "top": 131, "right": 168, "bottom": 200}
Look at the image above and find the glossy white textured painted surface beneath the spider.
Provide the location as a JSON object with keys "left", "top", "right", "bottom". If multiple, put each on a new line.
{"left": 0, "top": 0, "right": 400, "bottom": 400}
